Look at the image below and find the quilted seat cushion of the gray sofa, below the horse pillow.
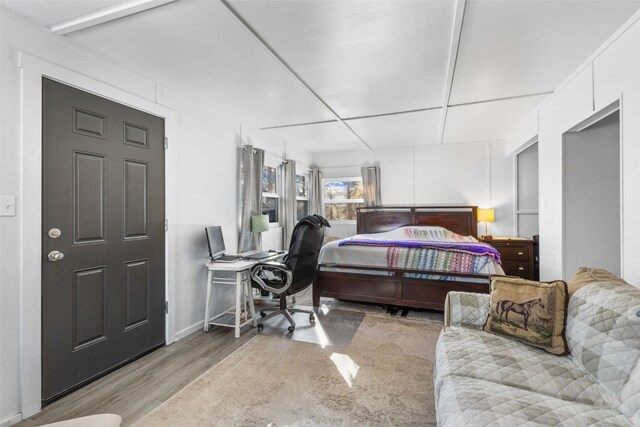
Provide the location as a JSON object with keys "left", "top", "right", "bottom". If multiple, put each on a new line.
{"left": 434, "top": 328, "right": 615, "bottom": 407}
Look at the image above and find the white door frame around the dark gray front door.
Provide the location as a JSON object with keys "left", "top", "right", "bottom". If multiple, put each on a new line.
{"left": 18, "top": 52, "right": 177, "bottom": 419}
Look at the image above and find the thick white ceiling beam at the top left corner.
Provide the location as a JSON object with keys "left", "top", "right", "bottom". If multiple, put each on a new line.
{"left": 49, "top": 0, "right": 176, "bottom": 35}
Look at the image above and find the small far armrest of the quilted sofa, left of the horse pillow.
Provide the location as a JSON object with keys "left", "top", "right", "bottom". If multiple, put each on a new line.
{"left": 444, "top": 292, "right": 491, "bottom": 329}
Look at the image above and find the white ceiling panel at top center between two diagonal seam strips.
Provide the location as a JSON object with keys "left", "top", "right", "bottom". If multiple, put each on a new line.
{"left": 231, "top": 0, "right": 455, "bottom": 118}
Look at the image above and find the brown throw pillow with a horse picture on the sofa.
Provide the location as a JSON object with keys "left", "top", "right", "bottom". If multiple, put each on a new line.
{"left": 484, "top": 276, "right": 568, "bottom": 355}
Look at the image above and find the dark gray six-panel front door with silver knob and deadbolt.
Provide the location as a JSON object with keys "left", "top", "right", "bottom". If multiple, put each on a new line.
{"left": 42, "top": 79, "right": 165, "bottom": 402}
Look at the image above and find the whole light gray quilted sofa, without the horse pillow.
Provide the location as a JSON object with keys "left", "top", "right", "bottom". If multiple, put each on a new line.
{"left": 434, "top": 282, "right": 640, "bottom": 426}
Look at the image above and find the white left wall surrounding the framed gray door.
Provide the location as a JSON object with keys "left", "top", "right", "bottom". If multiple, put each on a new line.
{"left": 0, "top": 11, "right": 310, "bottom": 426}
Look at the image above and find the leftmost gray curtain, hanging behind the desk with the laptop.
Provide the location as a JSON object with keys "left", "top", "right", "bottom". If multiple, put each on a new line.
{"left": 238, "top": 145, "right": 264, "bottom": 253}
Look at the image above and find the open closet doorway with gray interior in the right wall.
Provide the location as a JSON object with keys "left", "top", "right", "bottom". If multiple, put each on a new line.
{"left": 563, "top": 103, "right": 622, "bottom": 279}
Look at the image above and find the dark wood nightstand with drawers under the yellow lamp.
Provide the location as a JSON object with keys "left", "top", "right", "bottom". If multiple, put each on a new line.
{"left": 482, "top": 238, "right": 536, "bottom": 280}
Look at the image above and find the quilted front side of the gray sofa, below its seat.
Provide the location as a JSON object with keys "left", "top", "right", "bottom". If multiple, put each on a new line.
{"left": 436, "top": 376, "right": 632, "bottom": 427}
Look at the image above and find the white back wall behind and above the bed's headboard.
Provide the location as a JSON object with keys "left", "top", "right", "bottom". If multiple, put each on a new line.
{"left": 313, "top": 142, "right": 514, "bottom": 237}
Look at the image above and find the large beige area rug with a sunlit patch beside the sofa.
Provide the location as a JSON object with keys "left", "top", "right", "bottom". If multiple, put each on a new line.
{"left": 136, "top": 315, "right": 442, "bottom": 427}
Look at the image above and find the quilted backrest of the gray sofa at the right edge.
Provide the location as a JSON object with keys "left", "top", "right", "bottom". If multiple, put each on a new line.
{"left": 567, "top": 282, "right": 640, "bottom": 425}
